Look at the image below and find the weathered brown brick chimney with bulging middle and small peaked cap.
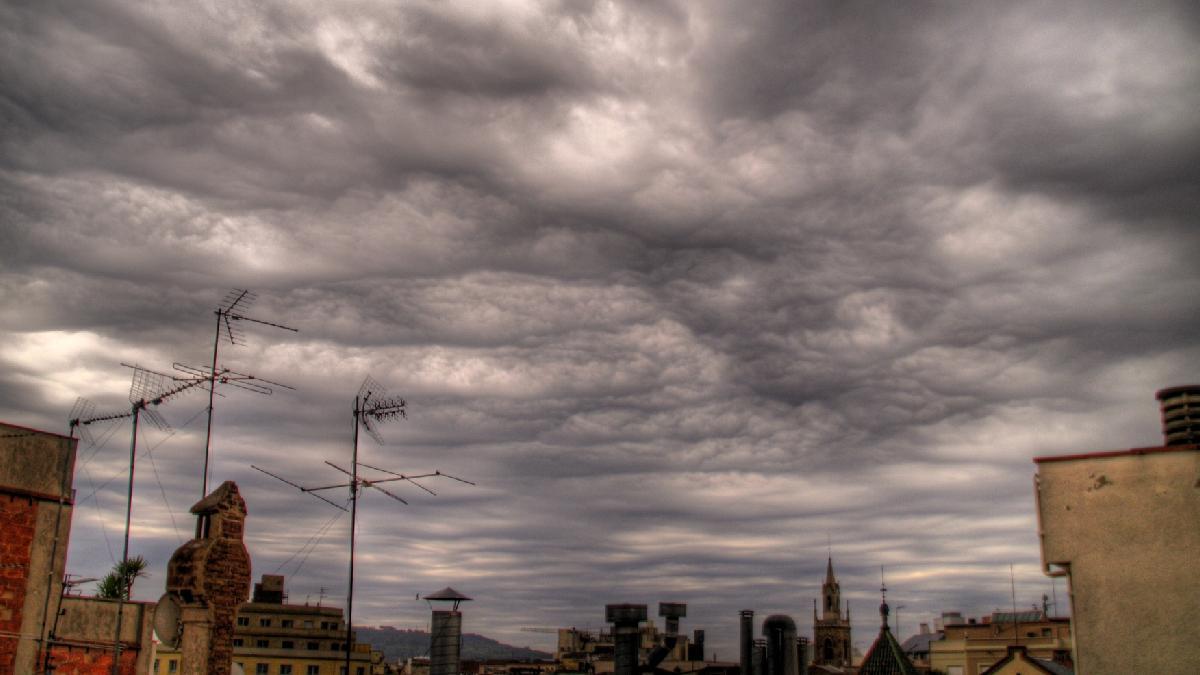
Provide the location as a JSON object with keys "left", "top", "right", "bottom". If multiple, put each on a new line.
{"left": 167, "top": 480, "right": 251, "bottom": 675}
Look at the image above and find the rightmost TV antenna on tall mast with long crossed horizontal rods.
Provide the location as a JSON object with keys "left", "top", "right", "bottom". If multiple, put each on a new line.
{"left": 251, "top": 376, "right": 474, "bottom": 673}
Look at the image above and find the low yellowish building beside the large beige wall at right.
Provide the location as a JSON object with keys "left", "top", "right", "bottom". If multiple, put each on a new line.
{"left": 929, "top": 610, "right": 1072, "bottom": 675}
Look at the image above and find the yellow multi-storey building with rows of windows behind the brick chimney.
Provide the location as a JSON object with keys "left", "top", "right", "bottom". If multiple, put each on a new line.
{"left": 151, "top": 574, "right": 385, "bottom": 675}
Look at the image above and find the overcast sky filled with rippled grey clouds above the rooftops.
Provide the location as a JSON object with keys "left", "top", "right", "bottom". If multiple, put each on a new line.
{"left": 0, "top": 0, "right": 1200, "bottom": 658}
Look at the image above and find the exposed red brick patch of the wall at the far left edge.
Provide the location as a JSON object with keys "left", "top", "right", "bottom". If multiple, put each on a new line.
{"left": 0, "top": 494, "right": 37, "bottom": 673}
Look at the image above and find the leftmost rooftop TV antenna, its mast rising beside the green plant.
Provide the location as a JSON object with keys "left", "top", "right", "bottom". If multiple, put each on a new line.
{"left": 68, "top": 363, "right": 208, "bottom": 675}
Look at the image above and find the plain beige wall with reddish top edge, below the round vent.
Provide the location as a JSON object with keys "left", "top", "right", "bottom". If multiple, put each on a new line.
{"left": 1036, "top": 446, "right": 1200, "bottom": 675}
